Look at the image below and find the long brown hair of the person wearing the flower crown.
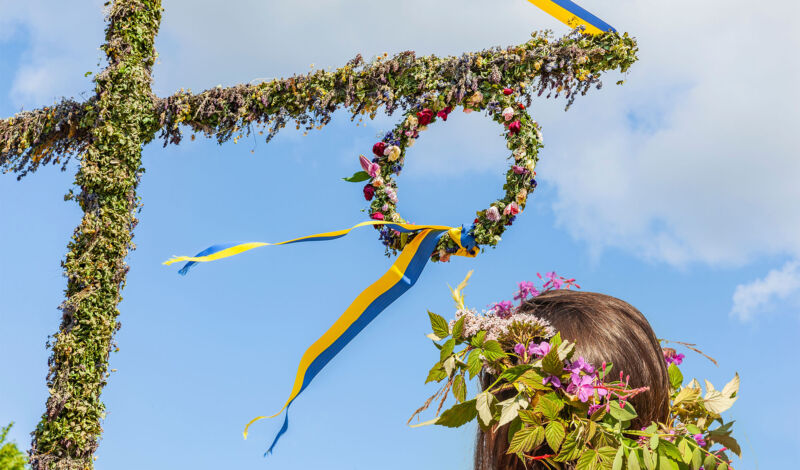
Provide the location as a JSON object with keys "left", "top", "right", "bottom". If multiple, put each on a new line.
{"left": 475, "top": 290, "right": 669, "bottom": 470}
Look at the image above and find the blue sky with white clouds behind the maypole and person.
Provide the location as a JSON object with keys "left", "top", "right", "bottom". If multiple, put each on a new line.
{"left": 0, "top": 0, "right": 800, "bottom": 470}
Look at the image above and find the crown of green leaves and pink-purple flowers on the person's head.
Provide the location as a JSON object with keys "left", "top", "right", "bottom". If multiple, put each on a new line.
{"left": 409, "top": 271, "right": 741, "bottom": 470}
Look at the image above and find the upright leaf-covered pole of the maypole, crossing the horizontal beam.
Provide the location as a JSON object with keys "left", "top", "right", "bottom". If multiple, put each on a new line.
{"left": 30, "top": 0, "right": 161, "bottom": 470}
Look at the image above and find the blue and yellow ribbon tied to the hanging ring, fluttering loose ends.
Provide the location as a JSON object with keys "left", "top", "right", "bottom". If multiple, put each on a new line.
{"left": 164, "top": 221, "right": 478, "bottom": 455}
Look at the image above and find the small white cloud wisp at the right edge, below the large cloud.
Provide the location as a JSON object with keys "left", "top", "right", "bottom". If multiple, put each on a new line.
{"left": 731, "top": 261, "right": 800, "bottom": 321}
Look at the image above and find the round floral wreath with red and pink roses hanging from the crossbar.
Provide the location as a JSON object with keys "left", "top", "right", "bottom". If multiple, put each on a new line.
{"left": 345, "top": 85, "right": 542, "bottom": 261}
